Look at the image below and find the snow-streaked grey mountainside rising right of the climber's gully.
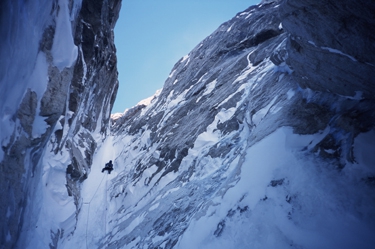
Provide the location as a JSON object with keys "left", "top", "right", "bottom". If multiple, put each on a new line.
{"left": 106, "top": 1, "right": 375, "bottom": 248}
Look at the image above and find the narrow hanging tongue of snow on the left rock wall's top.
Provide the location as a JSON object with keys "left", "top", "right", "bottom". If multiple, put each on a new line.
{"left": 51, "top": 0, "right": 78, "bottom": 71}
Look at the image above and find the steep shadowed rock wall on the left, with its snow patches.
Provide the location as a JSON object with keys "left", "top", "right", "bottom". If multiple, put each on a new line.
{"left": 0, "top": 0, "right": 120, "bottom": 248}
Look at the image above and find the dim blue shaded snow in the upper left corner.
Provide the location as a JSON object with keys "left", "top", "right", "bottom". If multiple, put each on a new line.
{"left": 0, "top": 0, "right": 52, "bottom": 117}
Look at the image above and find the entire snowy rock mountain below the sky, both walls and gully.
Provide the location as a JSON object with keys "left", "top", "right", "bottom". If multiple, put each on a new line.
{"left": 0, "top": 0, "right": 375, "bottom": 248}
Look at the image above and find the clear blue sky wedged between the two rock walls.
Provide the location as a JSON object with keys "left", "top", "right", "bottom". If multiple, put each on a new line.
{"left": 112, "top": 0, "right": 260, "bottom": 113}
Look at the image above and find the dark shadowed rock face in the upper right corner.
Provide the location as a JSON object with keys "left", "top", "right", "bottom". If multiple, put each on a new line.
{"left": 280, "top": 0, "right": 375, "bottom": 99}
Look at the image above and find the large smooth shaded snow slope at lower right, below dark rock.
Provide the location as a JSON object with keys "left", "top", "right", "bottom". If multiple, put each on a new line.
{"left": 176, "top": 127, "right": 375, "bottom": 249}
